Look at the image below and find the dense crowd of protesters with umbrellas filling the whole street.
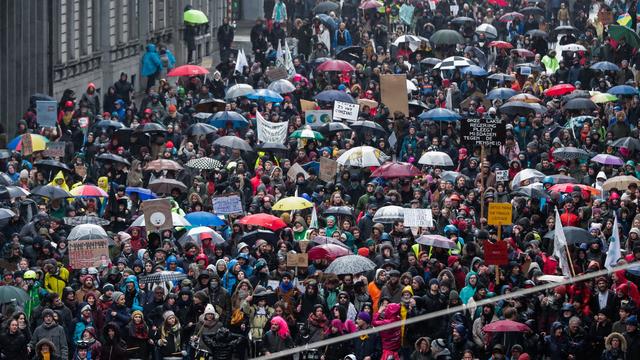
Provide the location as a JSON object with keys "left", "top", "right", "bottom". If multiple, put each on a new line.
{"left": 0, "top": 0, "right": 640, "bottom": 360}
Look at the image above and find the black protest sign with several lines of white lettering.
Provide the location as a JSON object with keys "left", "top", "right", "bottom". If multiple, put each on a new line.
{"left": 460, "top": 118, "right": 507, "bottom": 146}
